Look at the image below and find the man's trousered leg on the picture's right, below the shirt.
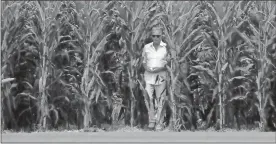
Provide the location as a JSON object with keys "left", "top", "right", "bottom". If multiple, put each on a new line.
{"left": 155, "top": 82, "right": 166, "bottom": 129}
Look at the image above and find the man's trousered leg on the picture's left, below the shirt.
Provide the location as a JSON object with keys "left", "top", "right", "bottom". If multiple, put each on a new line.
{"left": 145, "top": 83, "right": 155, "bottom": 128}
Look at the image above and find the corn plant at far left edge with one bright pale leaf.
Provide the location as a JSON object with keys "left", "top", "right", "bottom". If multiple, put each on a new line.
{"left": 1, "top": 3, "right": 20, "bottom": 127}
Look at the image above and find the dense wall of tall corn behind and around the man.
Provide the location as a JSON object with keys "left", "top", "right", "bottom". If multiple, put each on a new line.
{"left": 1, "top": 1, "right": 276, "bottom": 131}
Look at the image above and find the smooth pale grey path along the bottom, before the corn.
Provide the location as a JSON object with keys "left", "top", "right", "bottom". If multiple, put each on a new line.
{"left": 1, "top": 132, "right": 276, "bottom": 144}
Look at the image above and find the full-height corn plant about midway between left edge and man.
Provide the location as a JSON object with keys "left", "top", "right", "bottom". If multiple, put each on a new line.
{"left": 76, "top": 1, "right": 110, "bottom": 128}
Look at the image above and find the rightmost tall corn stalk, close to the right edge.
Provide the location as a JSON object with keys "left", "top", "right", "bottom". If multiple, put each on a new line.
{"left": 251, "top": 2, "right": 276, "bottom": 130}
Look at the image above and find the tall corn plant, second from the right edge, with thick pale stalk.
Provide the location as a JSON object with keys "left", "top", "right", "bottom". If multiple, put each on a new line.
{"left": 193, "top": 2, "right": 256, "bottom": 129}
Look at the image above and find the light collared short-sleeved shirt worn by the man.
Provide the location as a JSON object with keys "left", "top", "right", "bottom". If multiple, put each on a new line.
{"left": 142, "top": 41, "right": 168, "bottom": 85}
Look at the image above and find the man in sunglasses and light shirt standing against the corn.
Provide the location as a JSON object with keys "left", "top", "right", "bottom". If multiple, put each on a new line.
{"left": 142, "top": 27, "right": 168, "bottom": 130}
